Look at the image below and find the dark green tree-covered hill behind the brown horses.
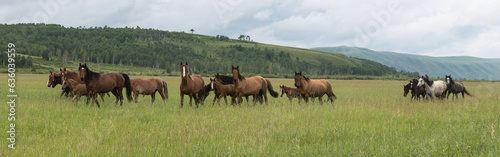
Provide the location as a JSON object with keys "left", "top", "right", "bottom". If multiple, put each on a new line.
{"left": 0, "top": 24, "right": 418, "bottom": 76}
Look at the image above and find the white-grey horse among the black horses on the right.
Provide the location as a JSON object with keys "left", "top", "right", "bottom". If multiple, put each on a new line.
{"left": 417, "top": 75, "right": 447, "bottom": 100}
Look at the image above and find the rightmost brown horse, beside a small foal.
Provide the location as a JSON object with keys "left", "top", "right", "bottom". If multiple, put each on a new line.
{"left": 295, "top": 72, "right": 337, "bottom": 104}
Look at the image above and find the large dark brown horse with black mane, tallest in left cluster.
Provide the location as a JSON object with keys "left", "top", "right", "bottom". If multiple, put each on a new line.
{"left": 78, "top": 63, "right": 132, "bottom": 107}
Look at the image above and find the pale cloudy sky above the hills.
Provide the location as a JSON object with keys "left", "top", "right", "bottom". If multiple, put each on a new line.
{"left": 0, "top": 0, "right": 500, "bottom": 58}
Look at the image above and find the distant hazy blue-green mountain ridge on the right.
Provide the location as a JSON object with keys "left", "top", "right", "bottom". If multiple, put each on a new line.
{"left": 313, "top": 46, "right": 500, "bottom": 80}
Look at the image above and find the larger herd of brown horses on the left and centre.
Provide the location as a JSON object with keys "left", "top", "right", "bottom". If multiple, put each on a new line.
{"left": 47, "top": 62, "right": 337, "bottom": 107}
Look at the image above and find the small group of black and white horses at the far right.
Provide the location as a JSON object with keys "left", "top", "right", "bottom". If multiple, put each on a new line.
{"left": 403, "top": 75, "right": 472, "bottom": 100}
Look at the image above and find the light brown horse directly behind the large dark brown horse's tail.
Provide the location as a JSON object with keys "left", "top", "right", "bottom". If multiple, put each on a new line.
{"left": 130, "top": 78, "right": 168, "bottom": 105}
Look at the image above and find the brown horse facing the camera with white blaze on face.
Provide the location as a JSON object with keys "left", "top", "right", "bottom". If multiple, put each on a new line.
{"left": 180, "top": 62, "right": 205, "bottom": 108}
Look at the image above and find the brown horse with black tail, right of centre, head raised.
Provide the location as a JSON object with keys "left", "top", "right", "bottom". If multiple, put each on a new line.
{"left": 231, "top": 66, "right": 278, "bottom": 105}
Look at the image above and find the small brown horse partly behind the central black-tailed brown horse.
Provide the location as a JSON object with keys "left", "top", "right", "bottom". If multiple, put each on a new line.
{"left": 210, "top": 78, "right": 236, "bottom": 106}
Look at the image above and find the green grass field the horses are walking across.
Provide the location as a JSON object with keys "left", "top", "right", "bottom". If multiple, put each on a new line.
{"left": 0, "top": 75, "right": 500, "bottom": 156}
